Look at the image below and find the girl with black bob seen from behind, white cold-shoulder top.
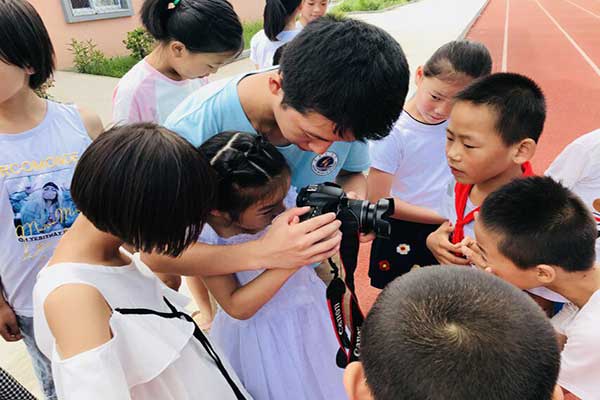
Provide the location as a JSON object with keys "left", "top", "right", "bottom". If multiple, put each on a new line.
{"left": 34, "top": 123, "right": 250, "bottom": 400}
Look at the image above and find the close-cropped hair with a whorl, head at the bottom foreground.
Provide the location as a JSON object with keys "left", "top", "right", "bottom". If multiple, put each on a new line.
{"left": 361, "top": 266, "right": 560, "bottom": 400}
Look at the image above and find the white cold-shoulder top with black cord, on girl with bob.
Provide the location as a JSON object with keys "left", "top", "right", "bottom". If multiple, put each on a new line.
{"left": 33, "top": 257, "right": 250, "bottom": 400}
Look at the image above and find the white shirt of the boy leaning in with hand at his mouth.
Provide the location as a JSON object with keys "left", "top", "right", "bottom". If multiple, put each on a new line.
{"left": 553, "top": 290, "right": 600, "bottom": 400}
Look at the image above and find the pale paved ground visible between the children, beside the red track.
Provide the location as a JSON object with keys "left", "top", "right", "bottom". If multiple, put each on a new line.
{"left": 0, "top": 0, "right": 487, "bottom": 398}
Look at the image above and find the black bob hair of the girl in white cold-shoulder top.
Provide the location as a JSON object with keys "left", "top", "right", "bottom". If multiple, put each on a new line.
{"left": 71, "top": 123, "right": 216, "bottom": 256}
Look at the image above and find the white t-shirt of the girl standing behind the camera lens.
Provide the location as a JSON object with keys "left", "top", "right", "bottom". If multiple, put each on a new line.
{"left": 369, "top": 111, "right": 452, "bottom": 209}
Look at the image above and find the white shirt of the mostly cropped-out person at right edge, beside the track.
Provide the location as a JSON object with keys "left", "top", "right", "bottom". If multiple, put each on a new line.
{"left": 546, "top": 129, "right": 600, "bottom": 264}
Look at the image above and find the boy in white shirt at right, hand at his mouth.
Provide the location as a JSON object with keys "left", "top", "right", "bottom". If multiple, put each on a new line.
{"left": 463, "top": 177, "right": 600, "bottom": 399}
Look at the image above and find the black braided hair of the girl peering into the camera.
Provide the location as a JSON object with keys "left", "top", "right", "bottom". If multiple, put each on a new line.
{"left": 200, "top": 132, "right": 290, "bottom": 221}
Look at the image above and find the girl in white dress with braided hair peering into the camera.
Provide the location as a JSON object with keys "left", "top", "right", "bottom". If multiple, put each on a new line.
{"left": 190, "top": 132, "right": 347, "bottom": 400}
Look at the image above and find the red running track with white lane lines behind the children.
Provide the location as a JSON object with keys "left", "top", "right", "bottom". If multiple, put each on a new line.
{"left": 356, "top": 0, "right": 600, "bottom": 311}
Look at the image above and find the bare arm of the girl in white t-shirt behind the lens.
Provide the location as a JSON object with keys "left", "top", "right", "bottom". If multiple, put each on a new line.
{"left": 367, "top": 168, "right": 445, "bottom": 224}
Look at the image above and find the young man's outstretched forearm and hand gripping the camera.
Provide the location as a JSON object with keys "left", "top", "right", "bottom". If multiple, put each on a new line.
{"left": 142, "top": 207, "right": 341, "bottom": 277}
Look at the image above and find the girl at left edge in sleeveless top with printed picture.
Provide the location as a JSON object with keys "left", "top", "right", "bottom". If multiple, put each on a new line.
{"left": 0, "top": 0, "right": 102, "bottom": 400}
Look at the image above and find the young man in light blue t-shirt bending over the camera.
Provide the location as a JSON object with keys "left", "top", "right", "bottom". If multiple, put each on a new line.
{"left": 147, "top": 17, "right": 409, "bottom": 275}
